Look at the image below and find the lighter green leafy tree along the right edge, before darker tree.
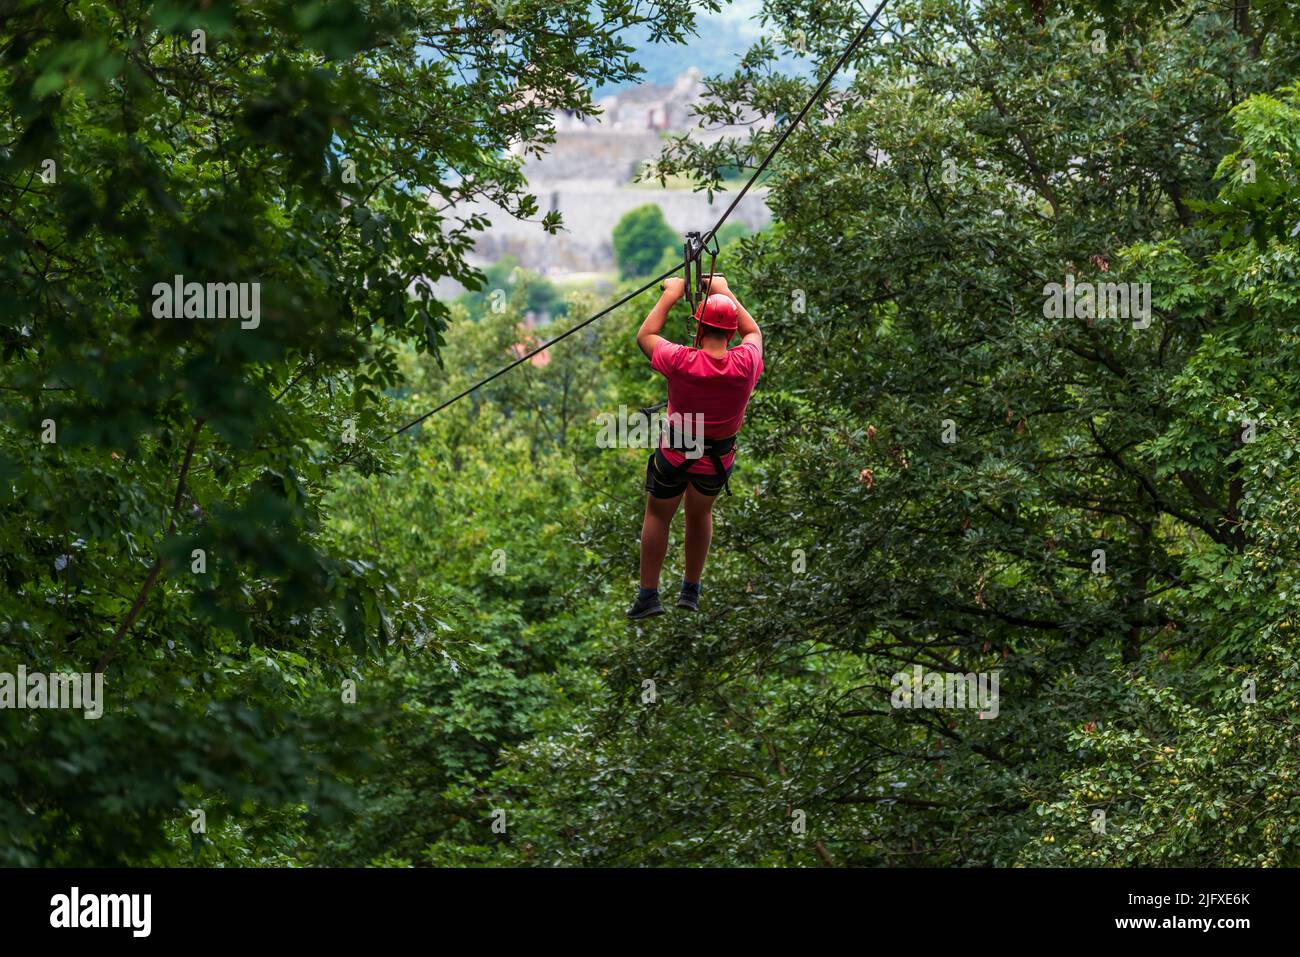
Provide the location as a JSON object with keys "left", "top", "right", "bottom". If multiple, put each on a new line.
{"left": 1022, "top": 86, "right": 1300, "bottom": 867}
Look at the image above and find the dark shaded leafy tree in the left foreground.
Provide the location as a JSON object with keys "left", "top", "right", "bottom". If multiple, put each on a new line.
{"left": 0, "top": 0, "right": 712, "bottom": 863}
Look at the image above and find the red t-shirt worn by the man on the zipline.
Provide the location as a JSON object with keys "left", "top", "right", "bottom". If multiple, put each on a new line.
{"left": 650, "top": 339, "right": 763, "bottom": 475}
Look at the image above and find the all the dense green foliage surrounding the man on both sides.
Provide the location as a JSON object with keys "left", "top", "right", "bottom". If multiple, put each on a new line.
{"left": 0, "top": 0, "right": 1300, "bottom": 866}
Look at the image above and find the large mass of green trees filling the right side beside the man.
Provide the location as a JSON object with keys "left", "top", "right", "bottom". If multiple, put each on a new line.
{"left": 475, "top": 0, "right": 1300, "bottom": 865}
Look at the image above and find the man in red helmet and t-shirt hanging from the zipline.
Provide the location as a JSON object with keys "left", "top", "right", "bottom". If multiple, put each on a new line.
{"left": 628, "top": 276, "right": 763, "bottom": 619}
